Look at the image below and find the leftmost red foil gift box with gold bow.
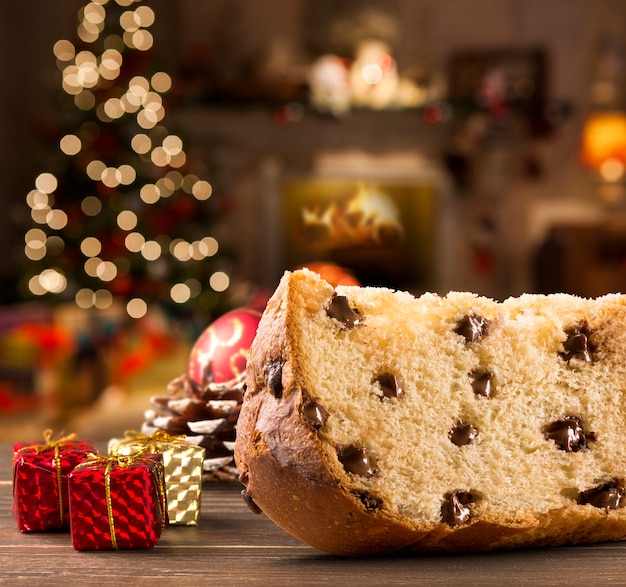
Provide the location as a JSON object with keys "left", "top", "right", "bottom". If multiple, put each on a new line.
{"left": 13, "top": 430, "right": 98, "bottom": 532}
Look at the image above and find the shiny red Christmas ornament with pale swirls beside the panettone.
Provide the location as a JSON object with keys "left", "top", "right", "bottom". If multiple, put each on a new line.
{"left": 187, "top": 308, "right": 263, "bottom": 384}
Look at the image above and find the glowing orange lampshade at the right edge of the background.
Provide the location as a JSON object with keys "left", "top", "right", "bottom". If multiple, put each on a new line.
{"left": 581, "top": 112, "right": 626, "bottom": 174}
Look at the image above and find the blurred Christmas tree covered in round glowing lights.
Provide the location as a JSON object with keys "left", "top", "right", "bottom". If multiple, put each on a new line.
{"left": 25, "top": 0, "right": 230, "bottom": 326}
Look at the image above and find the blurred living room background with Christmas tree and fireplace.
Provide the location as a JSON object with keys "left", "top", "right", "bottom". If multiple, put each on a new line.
{"left": 0, "top": 0, "right": 626, "bottom": 440}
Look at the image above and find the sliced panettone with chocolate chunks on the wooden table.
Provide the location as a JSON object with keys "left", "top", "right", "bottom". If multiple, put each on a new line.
{"left": 235, "top": 270, "right": 626, "bottom": 555}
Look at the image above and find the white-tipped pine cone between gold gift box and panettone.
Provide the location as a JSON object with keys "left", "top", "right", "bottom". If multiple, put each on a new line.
{"left": 142, "top": 366, "right": 245, "bottom": 481}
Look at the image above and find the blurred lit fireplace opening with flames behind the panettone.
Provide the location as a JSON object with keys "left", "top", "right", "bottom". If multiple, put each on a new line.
{"left": 266, "top": 155, "right": 450, "bottom": 293}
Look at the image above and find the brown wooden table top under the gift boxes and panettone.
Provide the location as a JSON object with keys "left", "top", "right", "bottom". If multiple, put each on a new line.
{"left": 0, "top": 443, "right": 626, "bottom": 587}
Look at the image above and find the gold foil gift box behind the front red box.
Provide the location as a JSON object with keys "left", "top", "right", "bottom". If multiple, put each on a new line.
{"left": 108, "top": 431, "right": 205, "bottom": 526}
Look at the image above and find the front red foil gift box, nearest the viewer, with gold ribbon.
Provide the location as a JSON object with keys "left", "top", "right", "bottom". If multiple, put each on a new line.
{"left": 69, "top": 454, "right": 168, "bottom": 550}
